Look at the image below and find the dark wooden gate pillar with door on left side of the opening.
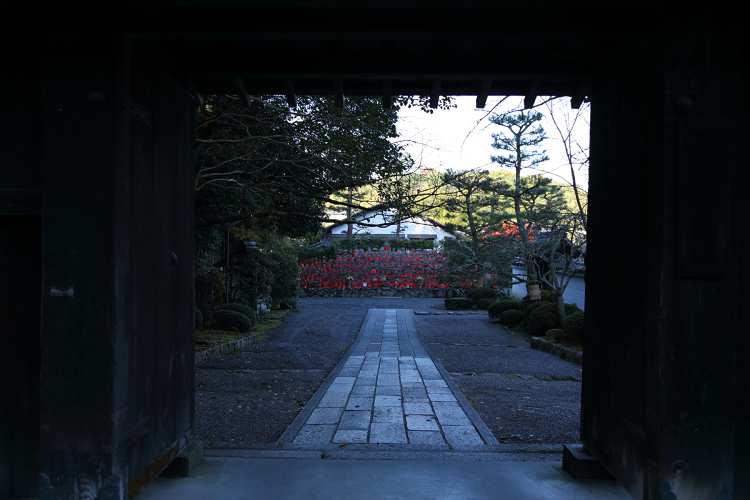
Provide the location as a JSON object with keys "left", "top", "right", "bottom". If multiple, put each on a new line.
{"left": 40, "top": 32, "right": 194, "bottom": 498}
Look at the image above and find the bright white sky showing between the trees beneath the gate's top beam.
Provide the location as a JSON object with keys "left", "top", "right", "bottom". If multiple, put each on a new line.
{"left": 397, "top": 96, "right": 589, "bottom": 189}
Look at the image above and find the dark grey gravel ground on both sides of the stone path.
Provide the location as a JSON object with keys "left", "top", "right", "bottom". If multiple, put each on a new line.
{"left": 195, "top": 298, "right": 581, "bottom": 446}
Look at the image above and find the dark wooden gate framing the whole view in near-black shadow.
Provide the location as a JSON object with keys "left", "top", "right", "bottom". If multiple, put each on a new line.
{"left": 0, "top": 0, "right": 750, "bottom": 499}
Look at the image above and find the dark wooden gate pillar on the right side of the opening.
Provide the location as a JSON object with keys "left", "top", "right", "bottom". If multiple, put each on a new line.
{"left": 581, "top": 12, "right": 750, "bottom": 499}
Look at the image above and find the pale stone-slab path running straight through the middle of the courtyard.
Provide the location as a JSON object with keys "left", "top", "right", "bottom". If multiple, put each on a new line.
{"left": 279, "top": 309, "right": 497, "bottom": 450}
